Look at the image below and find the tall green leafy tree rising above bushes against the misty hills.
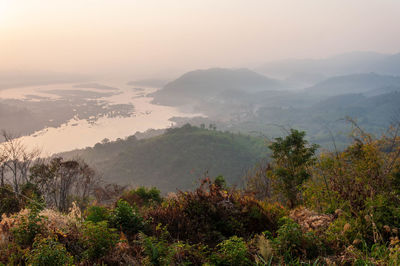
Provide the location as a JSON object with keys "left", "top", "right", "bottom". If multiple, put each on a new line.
{"left": 268, "top": 129, "right": 318, "bottom": 208}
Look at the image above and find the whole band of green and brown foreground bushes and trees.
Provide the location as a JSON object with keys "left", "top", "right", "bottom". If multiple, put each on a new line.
{"left": 0, "top": 122, "right": 400, "bottom": 265}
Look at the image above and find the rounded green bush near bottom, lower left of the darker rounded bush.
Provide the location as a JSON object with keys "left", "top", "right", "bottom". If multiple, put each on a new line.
{"left": 82, "top": 221, "right": 119, "bottom": 261}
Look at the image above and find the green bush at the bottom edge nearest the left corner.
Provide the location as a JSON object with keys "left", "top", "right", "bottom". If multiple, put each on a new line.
{"left": 27, "top": 237, "right": 73, "bottom": 266}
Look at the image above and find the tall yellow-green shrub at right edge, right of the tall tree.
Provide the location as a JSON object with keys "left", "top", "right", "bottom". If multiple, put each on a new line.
{"left": 308, "top": 129, "right": 400, "bottom": 214}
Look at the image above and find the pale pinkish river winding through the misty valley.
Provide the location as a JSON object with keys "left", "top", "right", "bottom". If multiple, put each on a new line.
{"left": 0, "top": 81, "right": 200, "bottom": 155}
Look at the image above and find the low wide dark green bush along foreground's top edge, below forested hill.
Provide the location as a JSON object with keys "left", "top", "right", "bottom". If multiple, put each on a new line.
{"left": 121, "top": 187, "right": 162, "bottom": 207}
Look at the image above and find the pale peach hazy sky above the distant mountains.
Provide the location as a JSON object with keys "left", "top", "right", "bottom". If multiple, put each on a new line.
{"left": 0, "top": 0, "right": 400, "bottom": 78}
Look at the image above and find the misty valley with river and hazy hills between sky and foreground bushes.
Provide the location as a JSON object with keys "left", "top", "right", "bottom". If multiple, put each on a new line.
{"left": 0, "top": 53, "right": 400, "bottom": 189}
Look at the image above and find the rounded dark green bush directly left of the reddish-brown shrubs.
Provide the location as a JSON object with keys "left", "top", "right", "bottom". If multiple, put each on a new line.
{"left": 111, "top": 200, "right": 144, "bottom": 235}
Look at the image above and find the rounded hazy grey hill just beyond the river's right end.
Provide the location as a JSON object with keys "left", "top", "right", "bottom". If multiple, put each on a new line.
{"left": 153, "top": 68, "right": 282, "bottom": 105}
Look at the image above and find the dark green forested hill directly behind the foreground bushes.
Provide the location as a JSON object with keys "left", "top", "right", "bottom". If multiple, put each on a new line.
{"left": 62, "top": 125, "right": 267, "bottom": 192}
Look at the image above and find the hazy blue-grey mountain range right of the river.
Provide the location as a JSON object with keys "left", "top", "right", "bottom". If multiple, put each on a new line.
{"left": 148, "top": 59, "right": 400, "bottom": 147}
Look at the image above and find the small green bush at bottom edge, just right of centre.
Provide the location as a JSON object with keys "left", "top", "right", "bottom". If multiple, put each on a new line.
{"left": 212, "top": 236, "right": 251, "bottom": 266}
